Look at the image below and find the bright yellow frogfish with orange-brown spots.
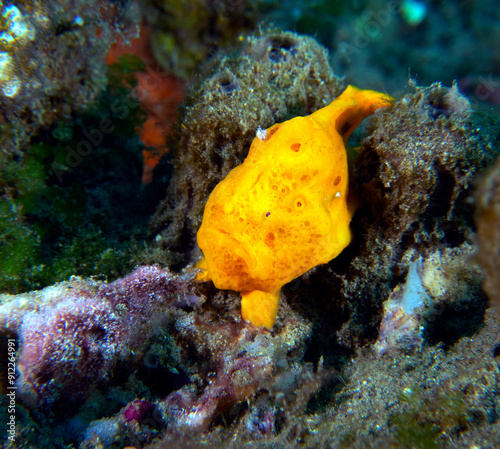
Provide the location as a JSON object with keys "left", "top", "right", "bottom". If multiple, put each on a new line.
{"left": 197, "top": 86, "right": 392, "bottom": 328}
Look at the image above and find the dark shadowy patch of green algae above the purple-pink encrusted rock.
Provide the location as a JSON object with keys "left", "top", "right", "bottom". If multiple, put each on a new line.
{"left": 0, "top": 59, "right": 159, "bottom": 293}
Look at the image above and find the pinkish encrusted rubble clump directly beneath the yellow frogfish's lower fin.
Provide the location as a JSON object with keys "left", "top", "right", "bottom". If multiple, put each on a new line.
{"left": 150, "top": 314, "right": 322, "bottom": 444}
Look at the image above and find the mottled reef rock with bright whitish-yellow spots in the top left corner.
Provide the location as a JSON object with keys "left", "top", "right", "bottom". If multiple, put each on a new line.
{"left": 0, "top": 0, "right": 135, "bottom": 155}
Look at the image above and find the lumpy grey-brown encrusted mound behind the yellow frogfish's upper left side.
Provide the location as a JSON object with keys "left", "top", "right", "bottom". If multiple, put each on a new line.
{"left": 146, "top": 31, "right": 342, "bottom": 268}
